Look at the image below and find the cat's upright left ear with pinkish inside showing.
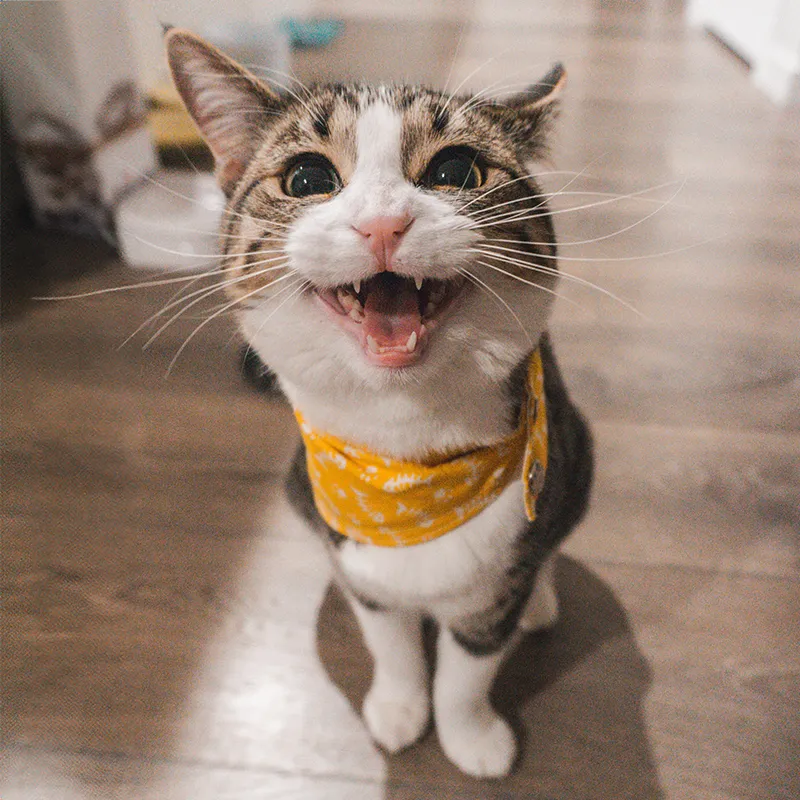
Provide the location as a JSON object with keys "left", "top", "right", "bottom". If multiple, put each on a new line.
{"left": 164, "top": 28, "right": 279, "bottom": 194}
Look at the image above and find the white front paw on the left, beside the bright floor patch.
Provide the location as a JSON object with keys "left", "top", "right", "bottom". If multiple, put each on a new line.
{"left": 363, "top": 684, "right": 431, "bottom": 753}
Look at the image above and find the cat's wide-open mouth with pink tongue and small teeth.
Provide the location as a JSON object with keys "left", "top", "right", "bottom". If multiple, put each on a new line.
{"left": 315, "top": 272, "right": 465, "bottom": 367}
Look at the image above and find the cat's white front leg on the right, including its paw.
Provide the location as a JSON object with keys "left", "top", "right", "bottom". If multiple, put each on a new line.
{"left": 433, "top": 627, "right": 517, "bottom": 778}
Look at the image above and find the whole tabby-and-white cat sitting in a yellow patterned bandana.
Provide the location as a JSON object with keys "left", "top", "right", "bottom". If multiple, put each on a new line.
{"left": 166, "top": 29, "right": 593, "bottom": 777}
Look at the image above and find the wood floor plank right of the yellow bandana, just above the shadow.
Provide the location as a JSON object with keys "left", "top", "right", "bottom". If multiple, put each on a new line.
{"left": 567, "top": 423, "right": 800, "bottom": 579}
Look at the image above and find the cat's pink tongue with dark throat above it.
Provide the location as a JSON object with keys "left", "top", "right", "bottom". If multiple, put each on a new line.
{"left": 362, "top": 272, "right": 422, "bottom": 354}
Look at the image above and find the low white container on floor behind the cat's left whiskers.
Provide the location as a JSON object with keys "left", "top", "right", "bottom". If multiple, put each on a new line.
{"left": 115, "top": 170, "right": 225, "bottom": 271}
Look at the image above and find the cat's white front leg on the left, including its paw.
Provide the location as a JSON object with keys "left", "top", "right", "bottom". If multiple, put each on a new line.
{"left": 349, "top": 596, "right": 430, "bottom": 753}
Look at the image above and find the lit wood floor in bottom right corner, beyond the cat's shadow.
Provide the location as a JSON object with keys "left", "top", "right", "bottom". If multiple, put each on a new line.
{"left": 597, "top": 566, "right": 800, "bottom": 800}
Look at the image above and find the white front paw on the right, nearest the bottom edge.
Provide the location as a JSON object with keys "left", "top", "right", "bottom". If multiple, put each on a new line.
{"left": 438, "top": 710, "right": 517, "bottom": 778}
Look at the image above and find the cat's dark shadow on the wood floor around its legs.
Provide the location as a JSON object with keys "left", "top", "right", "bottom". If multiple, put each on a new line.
{"left": 317, "top": 557, "right": 663, "bottom": 800}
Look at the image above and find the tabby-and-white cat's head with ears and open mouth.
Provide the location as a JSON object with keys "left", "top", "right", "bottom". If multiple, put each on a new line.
{"left": 167, "top": 30, "right": 564, "bottom": 391}
